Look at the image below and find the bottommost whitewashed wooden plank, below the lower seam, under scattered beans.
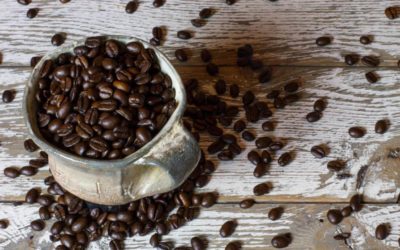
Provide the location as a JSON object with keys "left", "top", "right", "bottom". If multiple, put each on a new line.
{"left": 0, "top": 204, "right": 400, "bottom": 250}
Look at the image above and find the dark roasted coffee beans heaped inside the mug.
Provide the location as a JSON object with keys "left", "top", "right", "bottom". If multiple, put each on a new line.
{"left": 36, "top": 37, "right": 176, "bottom": 159}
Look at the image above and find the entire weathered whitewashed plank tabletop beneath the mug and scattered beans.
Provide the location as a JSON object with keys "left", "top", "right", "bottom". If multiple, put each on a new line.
{"left": 0, "top": 0, "right": 400, "bottom": 249}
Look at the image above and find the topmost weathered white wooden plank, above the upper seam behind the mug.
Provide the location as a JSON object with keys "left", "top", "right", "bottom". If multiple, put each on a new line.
{"left": 0, "top": 0, "right": 400, "bottom": 66}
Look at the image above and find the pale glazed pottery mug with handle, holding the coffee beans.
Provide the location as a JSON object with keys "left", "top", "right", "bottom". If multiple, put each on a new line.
{"left": 22, "top": 36, "right": 200, "bottom": 205}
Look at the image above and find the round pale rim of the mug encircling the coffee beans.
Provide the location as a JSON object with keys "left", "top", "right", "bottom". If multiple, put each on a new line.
{"left": 22, "top": 35, "right": 187, "bottom": 169}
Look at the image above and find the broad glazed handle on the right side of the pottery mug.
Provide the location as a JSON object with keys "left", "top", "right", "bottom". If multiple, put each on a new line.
{"left": 122, "top": 121, "right": 200, "bottom": 200}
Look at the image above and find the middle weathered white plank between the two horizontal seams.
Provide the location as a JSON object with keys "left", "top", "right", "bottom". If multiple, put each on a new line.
{"left": 0, "top": 66, "right": 400, "bottom": 202}
